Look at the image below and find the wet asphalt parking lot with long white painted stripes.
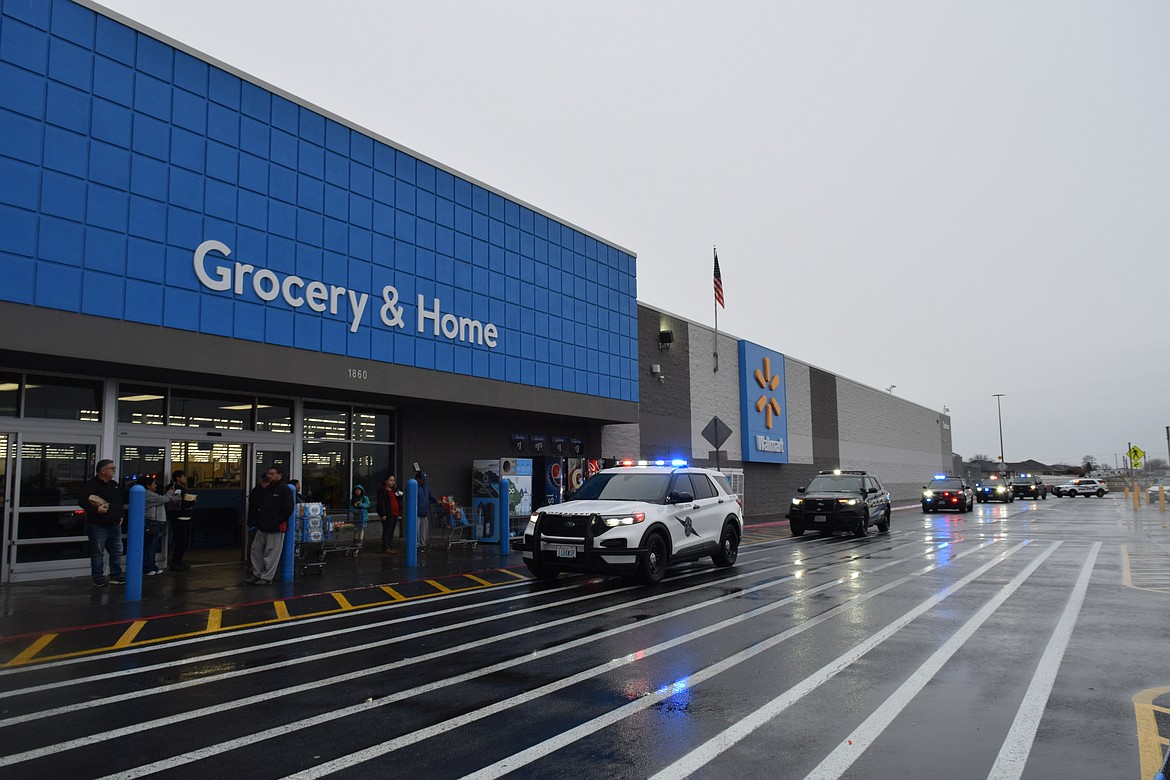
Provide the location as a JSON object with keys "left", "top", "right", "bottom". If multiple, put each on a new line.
{"left": 0, "top": 496, "right": 1170, "bottom": 780}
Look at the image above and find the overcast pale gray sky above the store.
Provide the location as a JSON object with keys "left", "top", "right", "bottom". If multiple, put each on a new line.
{"left": 103, "top": 0, "right": 1170, "bottom": 465}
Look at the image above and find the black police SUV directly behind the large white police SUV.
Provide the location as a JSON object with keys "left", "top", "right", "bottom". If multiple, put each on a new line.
{"left": 787, "top": 469, "right": 890, "bottom": 537}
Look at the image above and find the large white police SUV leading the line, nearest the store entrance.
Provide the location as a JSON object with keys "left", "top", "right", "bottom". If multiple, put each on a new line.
{"left": 515, "top": 461, "right": 743, "bottom": 585}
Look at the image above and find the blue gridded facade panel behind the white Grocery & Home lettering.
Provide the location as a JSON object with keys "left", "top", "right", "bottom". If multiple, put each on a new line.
{"left": 0, "top": 0, "right": 638, "bottom": 401}
